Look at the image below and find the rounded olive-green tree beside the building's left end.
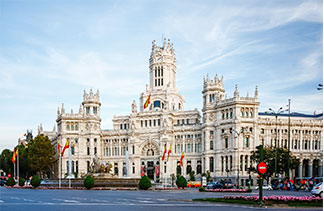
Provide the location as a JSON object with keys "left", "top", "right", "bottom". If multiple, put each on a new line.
{"left": 27, "top": 135, "right": 55, "bottom": 177}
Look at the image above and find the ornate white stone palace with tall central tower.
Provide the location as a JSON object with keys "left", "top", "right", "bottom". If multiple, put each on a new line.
{"left": 39, "top": 40, "right": 323, "bottom": 184}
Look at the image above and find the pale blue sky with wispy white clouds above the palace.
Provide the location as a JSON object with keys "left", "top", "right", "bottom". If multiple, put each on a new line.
{"left": 0, "top": 0, "right": 323, "bottom": 150}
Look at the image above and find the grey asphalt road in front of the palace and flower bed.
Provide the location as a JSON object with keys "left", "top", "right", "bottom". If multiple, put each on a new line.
{"left": 0, "top": 187, "right": 318, "bottom": 211}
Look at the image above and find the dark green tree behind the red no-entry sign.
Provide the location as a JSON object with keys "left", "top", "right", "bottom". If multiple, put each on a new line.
{"left": 251, "top": 147, "right": 300, "bottom": 180}
